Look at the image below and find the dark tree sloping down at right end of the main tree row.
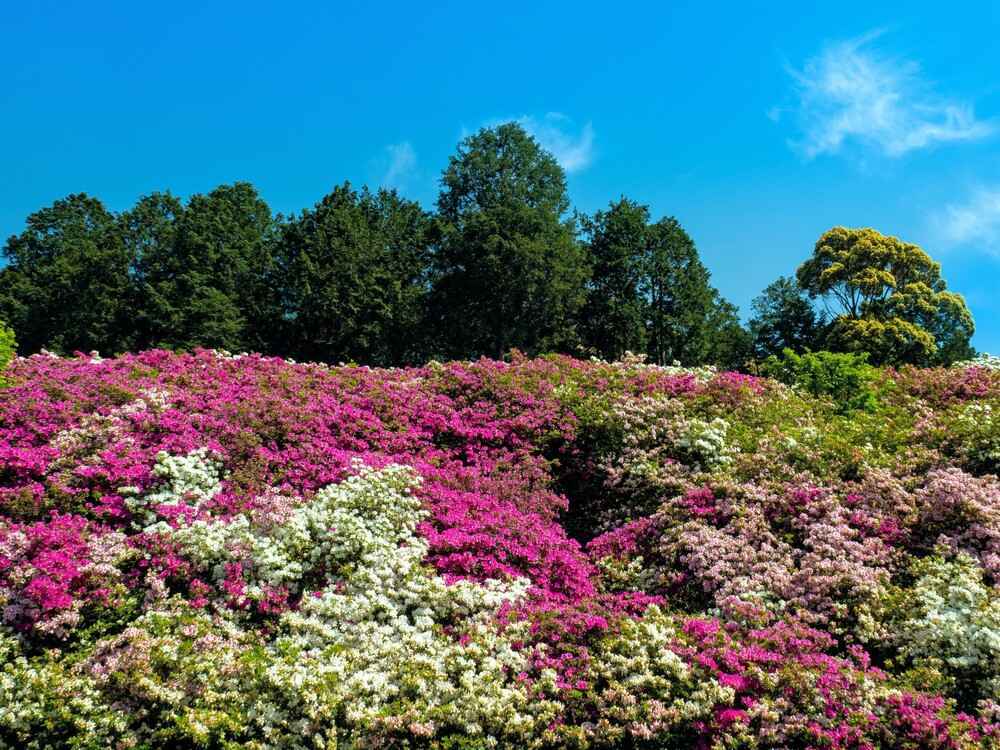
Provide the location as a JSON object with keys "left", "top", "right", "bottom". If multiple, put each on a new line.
{"left": 640, "top": 217, "right": 746, "bottom": 366}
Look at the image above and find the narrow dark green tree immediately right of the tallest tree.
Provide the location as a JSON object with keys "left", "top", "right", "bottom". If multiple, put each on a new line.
{"left": 580, "top": 198, "right": 649, "bottom": 359}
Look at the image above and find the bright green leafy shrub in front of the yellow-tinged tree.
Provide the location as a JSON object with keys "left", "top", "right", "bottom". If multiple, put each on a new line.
{"left": 761, "top": 349, "right": 879, "bottom": 414}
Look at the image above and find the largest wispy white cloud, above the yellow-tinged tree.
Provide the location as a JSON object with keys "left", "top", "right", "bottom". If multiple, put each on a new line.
{"left": 768, "top": 31, "right": 996, "bottom": 159}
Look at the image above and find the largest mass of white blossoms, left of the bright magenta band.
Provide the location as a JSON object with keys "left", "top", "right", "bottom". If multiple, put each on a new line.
{"left": 260, "top": 466, "right": 554, "bottom": 748}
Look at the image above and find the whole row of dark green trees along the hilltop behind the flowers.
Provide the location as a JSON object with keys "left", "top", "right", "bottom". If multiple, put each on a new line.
{"left": 0, "top": 124, "right": 971, "bottom": 368}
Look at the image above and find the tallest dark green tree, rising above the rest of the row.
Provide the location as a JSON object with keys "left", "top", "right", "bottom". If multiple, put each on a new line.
{"left": 428, "top": 123, "right": 587, "bottom": 357}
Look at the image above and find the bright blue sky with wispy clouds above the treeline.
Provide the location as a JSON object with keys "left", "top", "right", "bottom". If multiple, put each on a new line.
{"left": 0, "top": 0, "right": 1000, "bottom": 352}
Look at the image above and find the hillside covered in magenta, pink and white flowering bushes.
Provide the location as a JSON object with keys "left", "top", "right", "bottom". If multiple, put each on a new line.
{"left": 0, "top": 350, "right": 1000, "bottom": 750}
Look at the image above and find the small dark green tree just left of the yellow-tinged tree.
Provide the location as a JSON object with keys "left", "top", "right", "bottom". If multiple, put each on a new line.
{"left": 750, "top": 276, "right": 823, "bottom": 359}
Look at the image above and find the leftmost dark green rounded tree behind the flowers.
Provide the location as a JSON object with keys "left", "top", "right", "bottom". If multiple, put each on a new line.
{"left": 0, "top": 193, "right": 132, "bottom": 354}
